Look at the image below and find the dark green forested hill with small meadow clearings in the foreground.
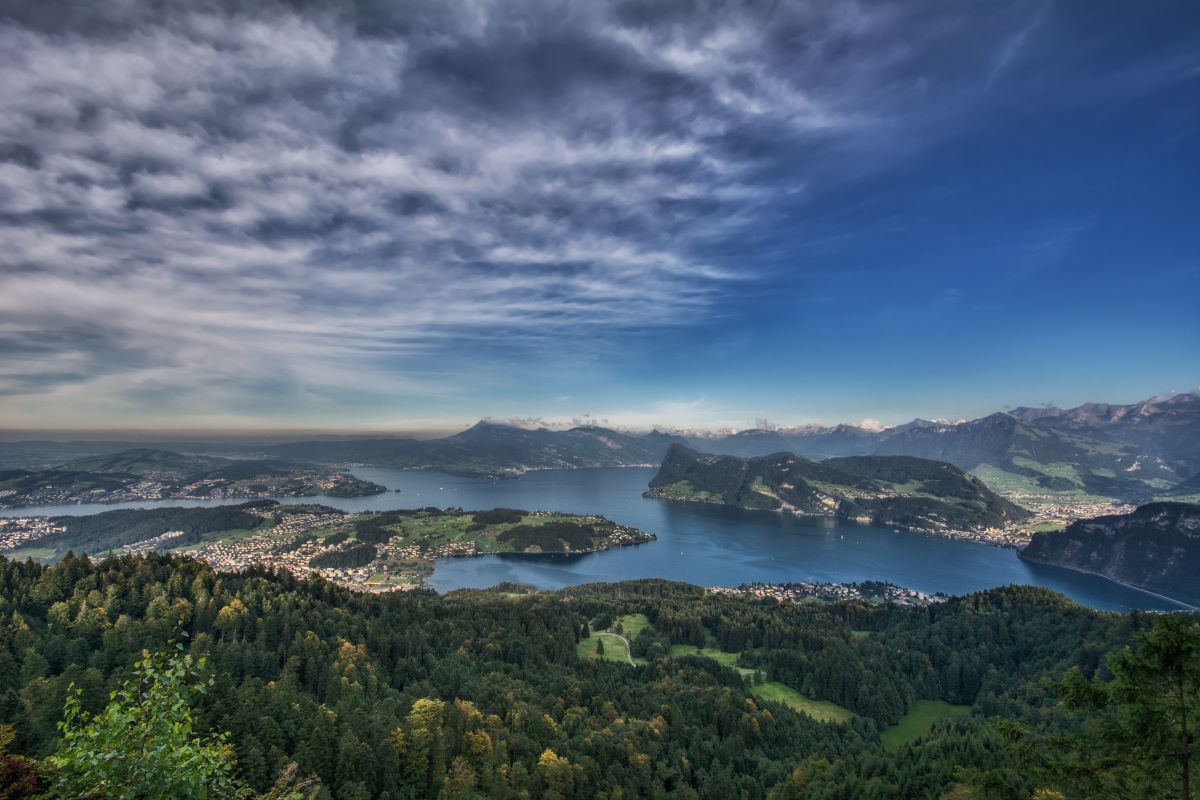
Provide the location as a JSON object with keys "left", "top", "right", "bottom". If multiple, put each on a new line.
{"left": 0, "top": 555, "right": 1148, "bottom": 800}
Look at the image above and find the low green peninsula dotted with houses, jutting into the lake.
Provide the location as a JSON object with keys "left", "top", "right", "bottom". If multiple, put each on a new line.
{"left": 0, "top": 500, "right": 655, "bottom": 591}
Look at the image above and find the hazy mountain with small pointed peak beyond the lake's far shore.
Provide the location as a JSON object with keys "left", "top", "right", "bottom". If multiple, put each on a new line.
{"left": 268, "top": 421, "right": 673, "bottom": 475}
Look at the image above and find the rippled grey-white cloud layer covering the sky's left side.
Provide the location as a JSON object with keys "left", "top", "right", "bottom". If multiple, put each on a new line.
{"left": 7, "top": 0, "right": 1161, "bottom": 425}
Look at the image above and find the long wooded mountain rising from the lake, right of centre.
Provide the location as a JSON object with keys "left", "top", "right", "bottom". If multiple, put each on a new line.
{"left": 646, "top": 445, "right": 1030, "bottom": 530}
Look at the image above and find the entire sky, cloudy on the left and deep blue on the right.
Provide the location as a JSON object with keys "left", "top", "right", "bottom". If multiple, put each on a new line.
{"left": 0, "top": 0, "right": 1200, "bottom": 431}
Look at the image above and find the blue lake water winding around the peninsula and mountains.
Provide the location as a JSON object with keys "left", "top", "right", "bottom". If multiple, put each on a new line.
{"left": 0, "top": 469, "right": 1177, "bottom": 610}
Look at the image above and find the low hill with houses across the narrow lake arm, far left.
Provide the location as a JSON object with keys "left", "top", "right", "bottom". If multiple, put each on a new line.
{"left": 0, "top": 449, "right": 384, "bottom": 509}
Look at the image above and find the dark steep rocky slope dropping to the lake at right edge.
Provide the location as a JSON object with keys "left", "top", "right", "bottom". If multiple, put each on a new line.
{"left": 1021, "top": 503, "right": 1200, "bottom": 603}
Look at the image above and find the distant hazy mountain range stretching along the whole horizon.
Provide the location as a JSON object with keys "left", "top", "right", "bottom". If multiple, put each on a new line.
{"left": 0, "top": 393, "right": 1200, "bottom": 501}
